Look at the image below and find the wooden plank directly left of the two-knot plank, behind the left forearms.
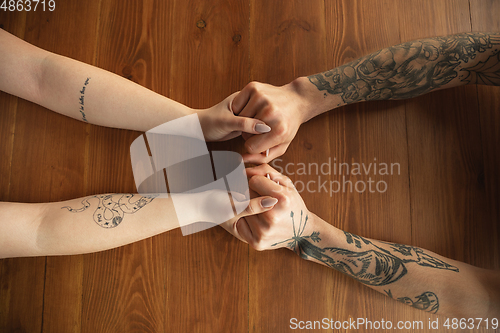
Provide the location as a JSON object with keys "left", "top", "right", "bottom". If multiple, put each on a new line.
{"left": 81, "top": 1, "right": 172, "bottom": 332}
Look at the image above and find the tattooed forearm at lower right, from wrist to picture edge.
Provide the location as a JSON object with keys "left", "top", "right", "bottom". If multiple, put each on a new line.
{"left": 294, "top": 211, "right": 500, "bottom": 318}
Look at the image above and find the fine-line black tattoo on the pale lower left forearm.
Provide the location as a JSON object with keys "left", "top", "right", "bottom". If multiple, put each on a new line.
{"left": 61, "top": 194, "right": 154, "bottom": 228}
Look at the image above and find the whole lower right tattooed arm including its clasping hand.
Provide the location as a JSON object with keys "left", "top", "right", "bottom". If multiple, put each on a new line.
{"left": 228, "top": 164, "right": 500, "bottom": 318}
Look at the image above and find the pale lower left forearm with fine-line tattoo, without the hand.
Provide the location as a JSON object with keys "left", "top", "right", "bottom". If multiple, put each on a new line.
{"left": 33, "top": 194, "right": 179, "bottom": 256}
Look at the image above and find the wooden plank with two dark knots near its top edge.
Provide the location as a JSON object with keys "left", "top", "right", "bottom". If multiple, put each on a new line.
{"left": 164, "top": 0, "right": 249, "bottom": 332}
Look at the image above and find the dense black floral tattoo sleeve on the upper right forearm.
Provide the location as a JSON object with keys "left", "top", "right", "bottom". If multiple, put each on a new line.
{"left": 308, "top": 33, "right": 500, "bottom": 104}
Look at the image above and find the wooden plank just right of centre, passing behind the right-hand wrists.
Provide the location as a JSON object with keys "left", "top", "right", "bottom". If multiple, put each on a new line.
{"left": 249, "top": 0, "right": 336, "bottom": 332}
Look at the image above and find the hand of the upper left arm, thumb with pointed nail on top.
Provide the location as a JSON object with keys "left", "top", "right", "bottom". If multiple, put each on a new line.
{"left": 195, "top": 93, "right": 271, "bottom": 141}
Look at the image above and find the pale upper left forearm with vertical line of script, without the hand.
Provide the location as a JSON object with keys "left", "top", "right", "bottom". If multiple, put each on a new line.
{"left": 39, "top": 54, "right": 193, "bottom": 131}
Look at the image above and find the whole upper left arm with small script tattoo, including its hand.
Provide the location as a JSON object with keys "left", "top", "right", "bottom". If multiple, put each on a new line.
{"left": 0, "top": 29, "right": 269, "bottom": 141}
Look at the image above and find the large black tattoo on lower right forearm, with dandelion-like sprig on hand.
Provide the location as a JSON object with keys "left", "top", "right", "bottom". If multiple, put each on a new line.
{"left": 272, "top": 211, "right": 459, "bottom": 286}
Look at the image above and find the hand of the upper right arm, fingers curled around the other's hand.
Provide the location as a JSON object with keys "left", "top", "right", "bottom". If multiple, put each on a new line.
{"left": 232, "top": 79, "right": 310, "bottom": 164}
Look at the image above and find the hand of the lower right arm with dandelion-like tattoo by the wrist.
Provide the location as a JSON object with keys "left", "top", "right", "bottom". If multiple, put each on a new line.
{"left": 221, "top": 164, "right": 312, "bottom": 251}
